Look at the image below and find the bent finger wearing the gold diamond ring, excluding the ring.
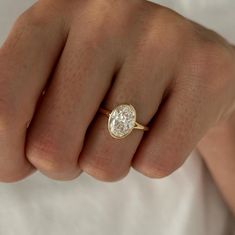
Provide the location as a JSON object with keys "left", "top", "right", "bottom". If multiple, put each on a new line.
{"left": 79, "top": 42, "right": 172, "bottom": 181}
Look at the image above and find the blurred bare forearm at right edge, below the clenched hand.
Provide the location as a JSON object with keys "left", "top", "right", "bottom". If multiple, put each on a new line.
{"left": 198, "top": 114, "right": 235, "bottom": 212}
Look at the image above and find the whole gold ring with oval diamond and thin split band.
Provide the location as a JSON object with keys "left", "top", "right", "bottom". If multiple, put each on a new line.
{"left": 99, "top": 104, "right": 149, "bottom": 139}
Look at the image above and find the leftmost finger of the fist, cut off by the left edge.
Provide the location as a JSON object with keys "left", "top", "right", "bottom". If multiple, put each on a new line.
{"left": 0, "top": 2, "right": 67, "bottom": 182}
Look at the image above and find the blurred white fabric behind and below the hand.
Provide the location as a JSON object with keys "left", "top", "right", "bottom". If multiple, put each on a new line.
{"left": 0, "top": 0, "right": 235, "bottom": 235}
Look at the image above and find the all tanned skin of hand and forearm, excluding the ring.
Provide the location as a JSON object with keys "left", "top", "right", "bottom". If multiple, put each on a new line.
{"left": 0, "top": 0, "right": 235, "bottom": 211}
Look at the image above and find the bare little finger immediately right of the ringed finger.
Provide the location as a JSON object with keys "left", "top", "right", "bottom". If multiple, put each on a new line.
{"left": 132, "top": 78, "right": 215, "bottom": 178}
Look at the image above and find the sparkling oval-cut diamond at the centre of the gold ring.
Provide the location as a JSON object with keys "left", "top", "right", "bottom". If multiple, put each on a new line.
{"left": 108, "top": 104, "right": 136, "bottom": 138}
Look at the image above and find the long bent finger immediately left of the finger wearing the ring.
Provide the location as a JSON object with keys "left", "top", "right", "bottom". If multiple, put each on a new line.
{"left": 27, "top": 22, "right": 121, "bottom": 180}
